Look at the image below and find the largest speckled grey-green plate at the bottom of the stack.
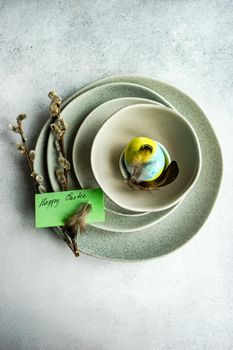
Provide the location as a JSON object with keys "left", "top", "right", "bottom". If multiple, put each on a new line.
{"left": 35, "top": 75, "right": 222, "bottom": 261}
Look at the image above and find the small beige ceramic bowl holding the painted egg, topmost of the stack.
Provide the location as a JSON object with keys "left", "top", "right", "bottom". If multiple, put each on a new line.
{"left": 91, "top": 104, "right": 201, "bottom": 212}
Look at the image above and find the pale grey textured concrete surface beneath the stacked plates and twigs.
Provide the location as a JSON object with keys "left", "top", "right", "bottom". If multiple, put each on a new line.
{"left": 0, "top": 0, "right": 233, "bottom": 350}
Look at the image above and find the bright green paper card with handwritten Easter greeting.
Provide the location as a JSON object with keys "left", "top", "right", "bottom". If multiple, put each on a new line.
{"left": 35, "top": 188, "right": 105, "bottom": 227}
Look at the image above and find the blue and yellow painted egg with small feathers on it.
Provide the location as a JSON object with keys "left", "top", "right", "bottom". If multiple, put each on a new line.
{"left": 120, "top": 137, "right": 170, "bottom": 182}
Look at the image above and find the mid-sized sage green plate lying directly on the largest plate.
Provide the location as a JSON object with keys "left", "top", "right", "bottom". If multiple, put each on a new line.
{"left": 47, "top": 83, "right": 177, "bottom": 232}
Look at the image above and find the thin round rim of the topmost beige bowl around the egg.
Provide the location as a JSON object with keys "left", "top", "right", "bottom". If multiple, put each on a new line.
{"left": 90, "top": 103, "right": 202, "bottom": 212}
